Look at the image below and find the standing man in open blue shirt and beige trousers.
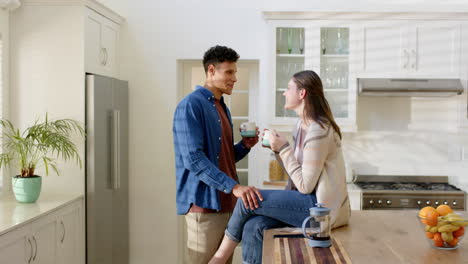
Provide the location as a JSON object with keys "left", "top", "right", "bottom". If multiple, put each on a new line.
{"left": 173, "top": 46, "right": 262, "bottom": 264}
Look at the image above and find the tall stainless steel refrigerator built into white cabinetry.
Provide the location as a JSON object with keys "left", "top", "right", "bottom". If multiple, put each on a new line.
{"left": 85, "top": 74, "right": 129, "bottom": 264}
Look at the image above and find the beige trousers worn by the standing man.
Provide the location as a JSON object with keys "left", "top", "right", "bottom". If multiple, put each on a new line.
{"left": 184, "top": 213, "right": 232, "bottom": 264}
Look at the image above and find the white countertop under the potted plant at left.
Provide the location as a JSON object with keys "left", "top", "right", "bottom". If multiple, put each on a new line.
{"left": 0, "top": 193, "right": 83, "bottom": 235}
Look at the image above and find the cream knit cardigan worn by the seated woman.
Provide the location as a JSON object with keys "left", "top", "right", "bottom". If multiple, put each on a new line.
{"left": 277, "top": 121, "right": 351, "bottom": 228}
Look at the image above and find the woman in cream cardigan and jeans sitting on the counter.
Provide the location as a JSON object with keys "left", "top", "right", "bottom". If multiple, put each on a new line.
{"left": 209, "top": 71, "right": 351, "bottom": 264}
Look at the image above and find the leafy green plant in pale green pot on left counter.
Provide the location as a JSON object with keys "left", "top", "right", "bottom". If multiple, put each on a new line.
{"left": 0, "top": 114, "right": 85, "bottom": 203}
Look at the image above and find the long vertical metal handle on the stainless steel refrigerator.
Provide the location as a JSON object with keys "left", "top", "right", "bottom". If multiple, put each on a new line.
{"left": 111, "top": 110, "right": 120, "bottom": 190}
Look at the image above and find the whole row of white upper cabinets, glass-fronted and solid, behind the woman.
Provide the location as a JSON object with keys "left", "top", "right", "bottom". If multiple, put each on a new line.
{"left": 263, "top": 12, "right": 468, "bottom": 132}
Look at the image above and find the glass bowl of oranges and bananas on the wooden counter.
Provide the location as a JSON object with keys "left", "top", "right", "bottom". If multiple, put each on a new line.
{"left": 417, "top": 204, "right": 468, "bottom": 250}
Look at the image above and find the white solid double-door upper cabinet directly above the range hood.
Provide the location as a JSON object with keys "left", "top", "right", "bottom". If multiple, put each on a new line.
{"left": 358, "top": 20, "right": 461, "bottom": 78}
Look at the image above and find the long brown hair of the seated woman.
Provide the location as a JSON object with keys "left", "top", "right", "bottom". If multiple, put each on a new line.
{"left": 293, "top": 71, "right": 341, "bottom": 139}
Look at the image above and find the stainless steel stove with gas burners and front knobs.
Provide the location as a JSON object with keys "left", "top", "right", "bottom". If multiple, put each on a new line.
{"left": 354, "top": 175, "right": 466, "bottom": 211}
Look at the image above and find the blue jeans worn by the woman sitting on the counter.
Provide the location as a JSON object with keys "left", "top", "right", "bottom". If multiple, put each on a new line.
{"left": 225, "top": 190, "right": 317, "bottom": 264}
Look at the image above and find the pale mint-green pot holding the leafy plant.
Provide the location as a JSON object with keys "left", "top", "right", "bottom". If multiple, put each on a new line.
{"left": 11, "top": 175, "right": 42, "bottom": 203}
